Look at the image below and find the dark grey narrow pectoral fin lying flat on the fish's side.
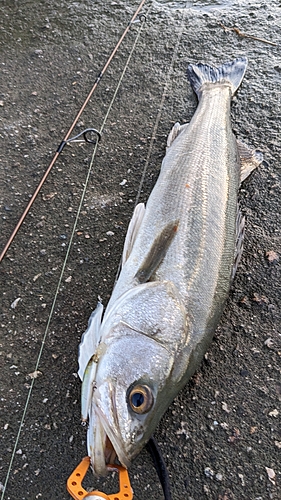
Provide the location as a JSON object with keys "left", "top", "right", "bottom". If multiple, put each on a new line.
{"left": 135, "top": 220, "right": 179, "bottom": 283}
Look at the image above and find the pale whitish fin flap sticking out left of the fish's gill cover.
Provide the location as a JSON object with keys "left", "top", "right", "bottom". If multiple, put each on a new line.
{"left": 78, "top": 302, "right": 103, "bottom": 380}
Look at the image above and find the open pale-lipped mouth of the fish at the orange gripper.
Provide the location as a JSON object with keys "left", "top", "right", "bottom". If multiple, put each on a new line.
{"left": 87, "top": 400, "right": 129, "bottom": 476}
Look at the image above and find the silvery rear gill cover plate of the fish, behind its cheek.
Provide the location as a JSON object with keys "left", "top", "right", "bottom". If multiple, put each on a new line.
{"left": 101, "top": 281, "right": 189, "bottom": 353}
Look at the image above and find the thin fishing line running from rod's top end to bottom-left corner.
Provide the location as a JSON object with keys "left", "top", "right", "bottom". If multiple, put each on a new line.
{"left": 1, "top": 12, "right": 149, "bottom": 500}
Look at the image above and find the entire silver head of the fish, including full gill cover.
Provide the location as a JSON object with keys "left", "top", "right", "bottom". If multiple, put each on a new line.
{"left": 82, "top": 282, "right": 189, "bottom": 476}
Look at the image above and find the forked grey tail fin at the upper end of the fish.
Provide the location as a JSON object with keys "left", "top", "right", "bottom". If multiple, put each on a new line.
{"left": 187, "top": 57, "right": 247, "bottom": 99}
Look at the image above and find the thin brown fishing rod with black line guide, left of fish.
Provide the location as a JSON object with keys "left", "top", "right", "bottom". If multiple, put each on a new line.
{"left": 0, "top": 0, "right": 146, "bottom": 263}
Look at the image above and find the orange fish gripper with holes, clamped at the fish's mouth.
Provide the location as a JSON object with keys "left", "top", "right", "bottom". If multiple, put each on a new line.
{"left": 66, "top": 457, "right": 133, "bottom": 500}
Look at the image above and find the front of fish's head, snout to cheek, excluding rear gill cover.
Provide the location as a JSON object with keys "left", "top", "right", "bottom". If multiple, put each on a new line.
{"left": 88, "top": 325, "right": 173, "bottom": 476}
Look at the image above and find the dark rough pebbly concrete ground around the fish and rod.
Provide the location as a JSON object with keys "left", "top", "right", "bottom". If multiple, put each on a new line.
{"left": 0, "top": 0, "right": 281, "bottom": 500}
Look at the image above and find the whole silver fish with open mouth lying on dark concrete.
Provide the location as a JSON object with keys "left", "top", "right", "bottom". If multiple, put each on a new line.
{"left": 78, "top": 57, "right": 263, "bottom": 476}
